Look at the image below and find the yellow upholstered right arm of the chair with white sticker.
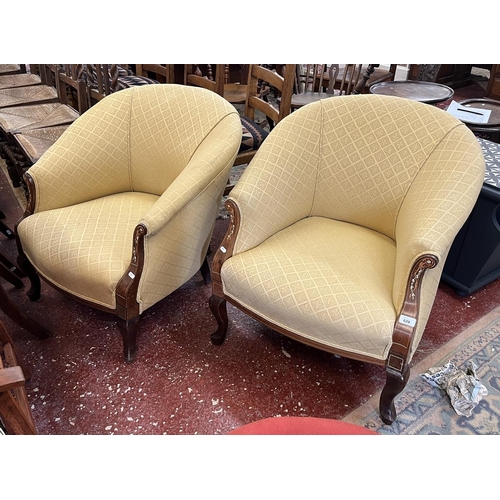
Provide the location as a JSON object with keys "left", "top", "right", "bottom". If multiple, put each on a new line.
{"left": 393, "top": 125, "right": 485, "bottom": 360}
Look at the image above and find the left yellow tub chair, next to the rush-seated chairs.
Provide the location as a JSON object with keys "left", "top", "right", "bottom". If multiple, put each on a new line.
{"left": 17, "top": 84, "right": 241, "bottom": 361}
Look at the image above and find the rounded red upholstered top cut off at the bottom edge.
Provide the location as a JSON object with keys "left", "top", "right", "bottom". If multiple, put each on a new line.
{"left": 229, "top": 417, "right": 377, "bottom": 435}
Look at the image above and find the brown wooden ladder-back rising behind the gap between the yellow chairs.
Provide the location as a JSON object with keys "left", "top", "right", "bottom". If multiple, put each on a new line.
{"left": 244, "top": 64, "right": 296, "bottom": 125}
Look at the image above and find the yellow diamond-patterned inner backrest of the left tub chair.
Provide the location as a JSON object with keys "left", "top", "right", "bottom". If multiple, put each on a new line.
{"left": 31, "top": 84, "right": 240, "bottom": 201}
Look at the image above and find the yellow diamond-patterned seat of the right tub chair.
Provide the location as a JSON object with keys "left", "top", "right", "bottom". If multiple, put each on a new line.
{"left": 221, "top": 217, "right": 396, "bottom": 361}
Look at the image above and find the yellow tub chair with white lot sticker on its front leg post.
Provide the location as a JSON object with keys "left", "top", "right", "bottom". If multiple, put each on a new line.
{"left": 209, "top": 95, "right": 484, "bottom": 423}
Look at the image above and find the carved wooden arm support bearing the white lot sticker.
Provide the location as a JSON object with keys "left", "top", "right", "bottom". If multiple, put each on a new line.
{"left": 387, "top": 254, "right": 438, "bottom": 373}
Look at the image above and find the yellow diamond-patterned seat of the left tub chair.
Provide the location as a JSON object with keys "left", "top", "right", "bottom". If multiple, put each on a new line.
{"left": 18, "top": 192, "right": 158, "bottom": 309}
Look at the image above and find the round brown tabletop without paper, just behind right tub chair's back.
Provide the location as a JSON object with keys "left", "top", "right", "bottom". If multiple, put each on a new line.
{"left": 370, "top": 80, "right": 454, "bottom": 104}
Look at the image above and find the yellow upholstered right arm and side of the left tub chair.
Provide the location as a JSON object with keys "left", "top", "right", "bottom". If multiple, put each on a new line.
{"left": 137, "top": 115, "right": 241, "bottom": 312}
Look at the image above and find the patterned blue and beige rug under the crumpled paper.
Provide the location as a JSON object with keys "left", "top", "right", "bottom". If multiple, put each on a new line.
{"left": 343, "top": 307, "right": 500, "bottom": 435}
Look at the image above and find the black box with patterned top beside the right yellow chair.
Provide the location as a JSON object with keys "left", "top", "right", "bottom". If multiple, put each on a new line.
{"left": 441, "top": 138, "right": 500, "bottom": 296}
